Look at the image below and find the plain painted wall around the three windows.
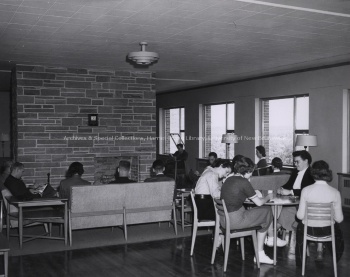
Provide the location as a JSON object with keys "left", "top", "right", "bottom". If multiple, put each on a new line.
{"left": 157, "top": 66, "right": 350, "bottom": 186}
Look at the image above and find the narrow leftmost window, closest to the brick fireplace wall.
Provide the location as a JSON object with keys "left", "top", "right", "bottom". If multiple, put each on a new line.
{"left": 164, "top": 108, "right": 185, "bottom": 153}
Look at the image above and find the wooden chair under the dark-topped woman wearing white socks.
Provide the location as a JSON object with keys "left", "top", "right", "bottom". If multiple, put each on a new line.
{"left": 211, "top": 199, "right": 261, "bottom": 272}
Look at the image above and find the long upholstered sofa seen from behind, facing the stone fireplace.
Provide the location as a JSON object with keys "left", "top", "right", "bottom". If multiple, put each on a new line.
{"left": 68, "top": 181, "right": 177, "bottom": 245}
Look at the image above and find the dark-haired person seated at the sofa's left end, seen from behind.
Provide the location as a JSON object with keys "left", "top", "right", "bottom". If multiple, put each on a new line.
{"left": 59, "top": 162, "right": 90, "bottom": 199}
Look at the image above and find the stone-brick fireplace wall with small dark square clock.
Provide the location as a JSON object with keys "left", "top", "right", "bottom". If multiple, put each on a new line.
{"left": 13, "top": 65, "right": 156, "bottom": 184}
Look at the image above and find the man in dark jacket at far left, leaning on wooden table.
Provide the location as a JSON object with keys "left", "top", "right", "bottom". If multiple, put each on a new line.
{"left": 4, "top": 162, "right": 57, "bottom": 200}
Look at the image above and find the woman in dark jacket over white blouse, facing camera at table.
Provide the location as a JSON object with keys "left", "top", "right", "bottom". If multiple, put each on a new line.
{"left": 277, "top": 150, "right": 315, "bottom": 231}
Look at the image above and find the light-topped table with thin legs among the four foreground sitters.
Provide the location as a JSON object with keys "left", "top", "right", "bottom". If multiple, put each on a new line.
{"left": 244, "top": 191, "right": 300, "bottom": 265}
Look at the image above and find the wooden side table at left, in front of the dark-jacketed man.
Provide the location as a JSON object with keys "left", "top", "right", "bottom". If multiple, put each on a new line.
{"left": 6, "top": 196, "right": 68, "bottom": 249}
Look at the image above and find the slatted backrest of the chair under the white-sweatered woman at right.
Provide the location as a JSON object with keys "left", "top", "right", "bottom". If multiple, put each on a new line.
{"left": 305, "top": 202, "right": 334, "bottom": 227}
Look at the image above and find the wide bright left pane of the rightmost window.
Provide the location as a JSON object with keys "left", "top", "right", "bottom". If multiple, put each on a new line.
{"left": 263, "top": 98, "right": 294, "bottom": 165}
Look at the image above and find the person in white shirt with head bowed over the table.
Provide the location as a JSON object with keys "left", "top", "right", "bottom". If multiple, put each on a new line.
{"left": 194, "top": 162, "right": 232, "bottom": 198}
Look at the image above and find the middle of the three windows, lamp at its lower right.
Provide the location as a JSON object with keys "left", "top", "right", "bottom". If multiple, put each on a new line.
{"left": 203, "top": 103, "right": 235, "bottom": 158}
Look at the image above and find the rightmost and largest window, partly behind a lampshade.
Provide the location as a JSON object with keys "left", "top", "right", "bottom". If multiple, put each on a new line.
{"left": 262, "top": 96, "right": 309, "bottom": 165}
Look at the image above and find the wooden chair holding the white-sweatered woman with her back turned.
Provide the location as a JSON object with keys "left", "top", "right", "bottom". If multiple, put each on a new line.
{"left": 301, "top": 202, "right": 337, "bottom": 277}
